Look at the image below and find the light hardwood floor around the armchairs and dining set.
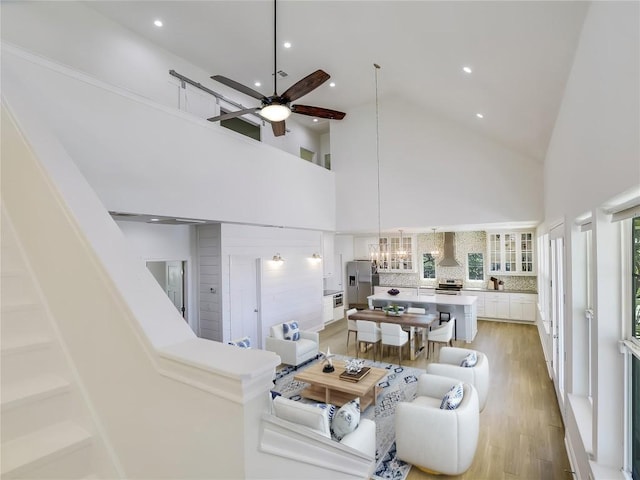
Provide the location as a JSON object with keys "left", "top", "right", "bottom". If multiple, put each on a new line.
{"left": 320, "top": 320, "right": 572, "bottom": 480}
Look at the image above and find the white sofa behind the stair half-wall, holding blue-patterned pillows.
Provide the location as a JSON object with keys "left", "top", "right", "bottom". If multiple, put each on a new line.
{"left": 273, "top": 396, "right": 376, "bottom": 459}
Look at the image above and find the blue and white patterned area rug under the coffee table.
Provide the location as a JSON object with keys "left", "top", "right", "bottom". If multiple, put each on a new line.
{"left": 273, "top": 355, "right": 424, "bottom": 480}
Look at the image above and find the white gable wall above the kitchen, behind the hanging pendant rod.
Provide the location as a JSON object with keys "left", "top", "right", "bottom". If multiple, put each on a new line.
{"left": 331, "top": 94, "right": 543, "bottom": 233}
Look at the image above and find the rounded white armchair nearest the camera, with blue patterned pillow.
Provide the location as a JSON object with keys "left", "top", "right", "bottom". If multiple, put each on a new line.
{"left": 395, "top": 373, "right": 480, "bottom": 475}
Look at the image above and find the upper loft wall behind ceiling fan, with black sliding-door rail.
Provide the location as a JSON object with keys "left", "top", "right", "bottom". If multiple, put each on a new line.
{"left": 0, "top": 2, "right": 320, "bottom": 161}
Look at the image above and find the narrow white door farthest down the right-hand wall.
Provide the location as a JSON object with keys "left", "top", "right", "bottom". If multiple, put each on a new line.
{"left": 549, "top": 226, "right": 565, "bottom": 408}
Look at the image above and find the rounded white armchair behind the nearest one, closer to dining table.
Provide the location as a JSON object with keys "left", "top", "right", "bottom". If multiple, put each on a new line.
{"left": 427, "top": 347, "right": 489, "bottom": 411}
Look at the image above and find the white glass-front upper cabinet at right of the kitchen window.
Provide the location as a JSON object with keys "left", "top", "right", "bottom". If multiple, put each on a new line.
{"left": 487, "top": 232, "right": 536, "bottom": 275}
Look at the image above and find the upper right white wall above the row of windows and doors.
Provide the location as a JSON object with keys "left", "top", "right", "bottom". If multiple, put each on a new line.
{"left": 544, "top": 2, "right": 640, "bottom": 222}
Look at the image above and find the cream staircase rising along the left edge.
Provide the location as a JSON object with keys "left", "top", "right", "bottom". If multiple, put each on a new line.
{"left": 0, "top": 210, "right": 121, "bottom": 479}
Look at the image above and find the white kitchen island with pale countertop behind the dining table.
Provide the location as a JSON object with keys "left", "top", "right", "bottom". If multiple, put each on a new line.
{"left": 367, "top": 293, "right": 478, "bottom": 343}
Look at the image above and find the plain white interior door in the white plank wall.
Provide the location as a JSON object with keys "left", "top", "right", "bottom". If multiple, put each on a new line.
{"left": 229, "top": 255, "right": 262, "bottom": 348}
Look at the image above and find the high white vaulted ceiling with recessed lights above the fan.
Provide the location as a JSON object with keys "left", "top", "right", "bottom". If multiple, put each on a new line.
{"left": 87, "top": 0, "right": 588, "bottom": 162}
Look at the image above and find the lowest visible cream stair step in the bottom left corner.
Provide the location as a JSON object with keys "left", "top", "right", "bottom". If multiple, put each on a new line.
{"left": 2, "top": 422, "right": 92, "bottom": 477}
